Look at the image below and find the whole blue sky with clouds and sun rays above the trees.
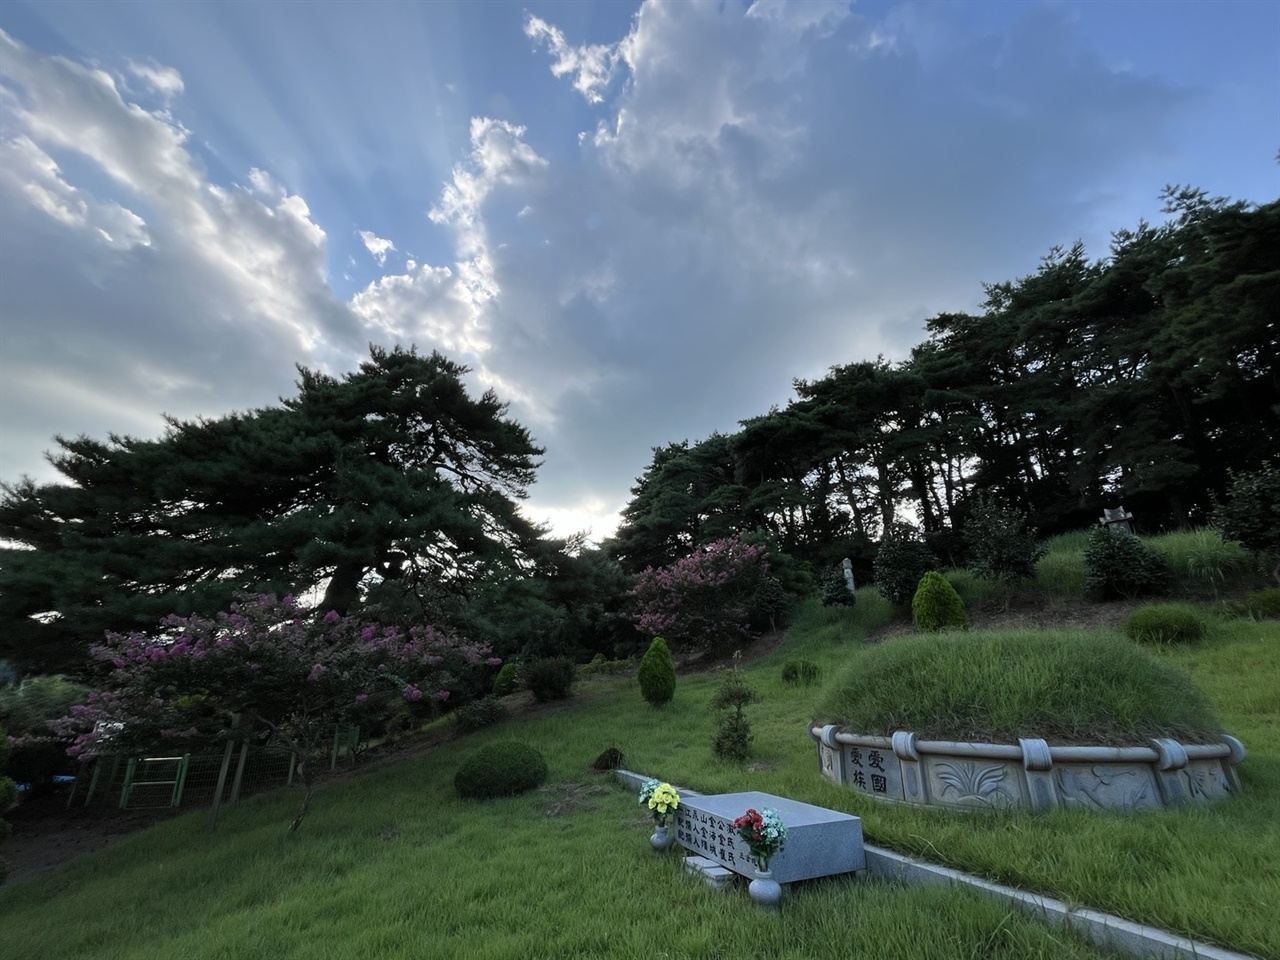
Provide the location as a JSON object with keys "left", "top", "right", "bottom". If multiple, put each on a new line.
{"left": 0, "top": 0, "right": 1280, "bottom": 540}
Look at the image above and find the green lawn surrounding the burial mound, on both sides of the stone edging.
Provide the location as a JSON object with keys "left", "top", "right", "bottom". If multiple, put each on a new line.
{"left": 0, "top": 591, "right": 1280, "bottom": 960}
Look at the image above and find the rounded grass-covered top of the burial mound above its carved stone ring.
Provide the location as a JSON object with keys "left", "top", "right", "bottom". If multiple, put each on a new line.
{"left": 820, "top": 630, "right": 1221, "bottom": 745}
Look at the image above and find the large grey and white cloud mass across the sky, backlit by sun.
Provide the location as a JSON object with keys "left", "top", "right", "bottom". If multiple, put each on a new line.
{"left": 0, "top": 3, "right": 1208, "bottom": 536}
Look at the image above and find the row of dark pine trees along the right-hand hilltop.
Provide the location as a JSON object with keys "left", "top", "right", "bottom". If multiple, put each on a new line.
{"left": 609, "top": 187, "right": 1280, "bottom": 571}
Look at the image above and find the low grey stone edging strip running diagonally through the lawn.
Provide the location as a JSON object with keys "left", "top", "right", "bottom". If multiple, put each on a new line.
{"left": 614, "top": 769, "right": 1257, "bottom": 960}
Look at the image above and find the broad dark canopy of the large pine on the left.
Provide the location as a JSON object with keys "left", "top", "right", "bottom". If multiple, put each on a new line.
{"left": 0, "top": 347, "right": 543, "bottom": 672}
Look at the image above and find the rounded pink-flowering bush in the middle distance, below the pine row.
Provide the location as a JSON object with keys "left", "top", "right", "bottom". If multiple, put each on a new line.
{"left": 631, "top": 536, "right": 769, "bottom": 649}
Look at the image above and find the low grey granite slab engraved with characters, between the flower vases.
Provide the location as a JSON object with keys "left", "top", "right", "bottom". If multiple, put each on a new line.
{"left": 675, "top": 791, "right": 867, "bottom": 883}
